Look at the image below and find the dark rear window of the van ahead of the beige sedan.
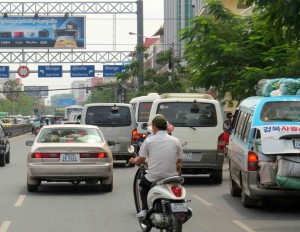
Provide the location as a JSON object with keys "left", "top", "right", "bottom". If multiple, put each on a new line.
{"left": 85, "top": 106, "right": 131, "bottom": 127}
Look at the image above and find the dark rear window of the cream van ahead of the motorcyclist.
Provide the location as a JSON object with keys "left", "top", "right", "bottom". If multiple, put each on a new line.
{"left": 157, "top": 102, "right": 217, "bottom": 127}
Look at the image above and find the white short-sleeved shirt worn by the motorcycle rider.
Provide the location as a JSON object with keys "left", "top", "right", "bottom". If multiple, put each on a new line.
{"left": 139, "top": 130, "right": 183, "bottom": 182}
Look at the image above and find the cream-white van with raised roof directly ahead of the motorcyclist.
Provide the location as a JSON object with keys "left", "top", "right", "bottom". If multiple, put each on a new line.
{"left": 149, "top": 93, "right": 225, "bottom": 183}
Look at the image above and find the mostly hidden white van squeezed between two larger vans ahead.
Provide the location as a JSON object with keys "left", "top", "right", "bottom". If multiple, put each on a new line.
{"left": 129, "top": 93, "right": 159, "bottom": 142}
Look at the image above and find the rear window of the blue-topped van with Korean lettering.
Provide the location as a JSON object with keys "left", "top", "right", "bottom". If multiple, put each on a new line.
{"left": 260, "top": 101, "right": 300, "bottom": 122}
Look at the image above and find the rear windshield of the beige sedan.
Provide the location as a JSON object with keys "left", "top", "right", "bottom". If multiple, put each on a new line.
{"left": 37, "top": 127, "right": 104, "bottom": 143}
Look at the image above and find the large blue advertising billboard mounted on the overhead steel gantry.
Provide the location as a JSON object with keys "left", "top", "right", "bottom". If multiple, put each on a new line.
{"left": 0, "top": 16, "right": 85, "bottom": 49}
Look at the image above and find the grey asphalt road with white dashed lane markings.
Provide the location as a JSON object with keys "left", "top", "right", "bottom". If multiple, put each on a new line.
{"left": 0, "top": 134, "right": 300, "bottom": 232}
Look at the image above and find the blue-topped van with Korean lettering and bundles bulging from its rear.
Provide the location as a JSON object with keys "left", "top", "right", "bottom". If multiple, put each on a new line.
{"left": 224, "top": 96, "right": 300, "bottom": 207}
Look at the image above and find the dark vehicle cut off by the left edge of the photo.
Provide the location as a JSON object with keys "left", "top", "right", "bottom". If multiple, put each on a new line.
{"left": 0, "top": 125, "right": 12, "bottom": 167}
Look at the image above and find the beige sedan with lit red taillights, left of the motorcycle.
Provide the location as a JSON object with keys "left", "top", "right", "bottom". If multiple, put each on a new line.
{"left": 26, "top": 124, "right": 113, "bottom": 192}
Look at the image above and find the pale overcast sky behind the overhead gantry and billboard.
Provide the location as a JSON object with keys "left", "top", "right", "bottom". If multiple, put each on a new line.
{"left": 2, "top": 0, "right": 163, "bottom": 101}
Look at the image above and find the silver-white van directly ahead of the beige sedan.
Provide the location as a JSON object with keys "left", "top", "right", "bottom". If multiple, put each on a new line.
{"left": 80, "top": 103, "right": 137, "bottom": 167}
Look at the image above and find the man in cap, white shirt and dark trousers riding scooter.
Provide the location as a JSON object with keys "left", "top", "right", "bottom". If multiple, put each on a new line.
{"left": 129, "top": 114, "right": 183, "bottom": 218}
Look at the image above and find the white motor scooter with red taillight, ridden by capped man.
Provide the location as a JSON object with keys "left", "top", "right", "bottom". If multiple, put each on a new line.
{"left": 128, "top": 145, "right": 192, "bottom": 232}
